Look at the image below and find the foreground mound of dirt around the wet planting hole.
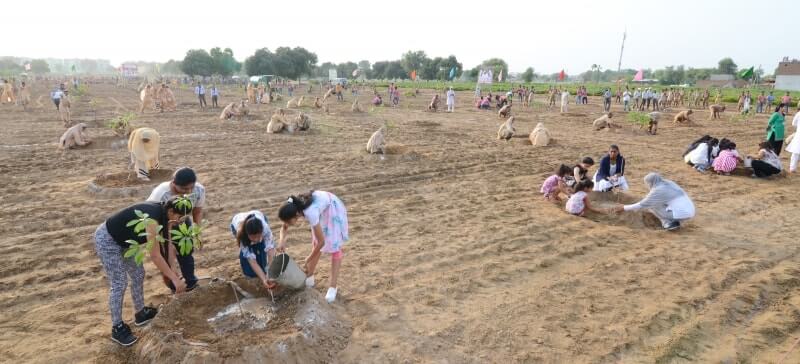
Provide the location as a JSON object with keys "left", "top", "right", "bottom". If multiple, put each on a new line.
{"left": 136, "top": 282, "right": 352, "bottom": 363}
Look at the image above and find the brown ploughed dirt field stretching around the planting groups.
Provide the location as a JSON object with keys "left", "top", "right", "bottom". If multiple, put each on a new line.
{"left": 0, "top": 83, "right": 800, "bottom": 363}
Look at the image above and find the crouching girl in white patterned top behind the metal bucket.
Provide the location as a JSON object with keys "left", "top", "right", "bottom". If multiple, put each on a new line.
{"left": 231, "top": 210, "right": 275, "bottom": 289}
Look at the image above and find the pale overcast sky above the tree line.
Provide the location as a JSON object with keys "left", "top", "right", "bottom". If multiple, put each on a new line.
{"left": 0, "top": 0, "right": 800, "bottom": 74}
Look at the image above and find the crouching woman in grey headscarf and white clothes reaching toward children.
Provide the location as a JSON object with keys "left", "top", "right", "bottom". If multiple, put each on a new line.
{"left": 614, "top": 172, "right": 695, "bottom": 230}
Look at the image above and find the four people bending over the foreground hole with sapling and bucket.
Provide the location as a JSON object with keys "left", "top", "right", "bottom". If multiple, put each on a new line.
{"left": 94, "top": 167, "right": 349, "bottom": 346}
